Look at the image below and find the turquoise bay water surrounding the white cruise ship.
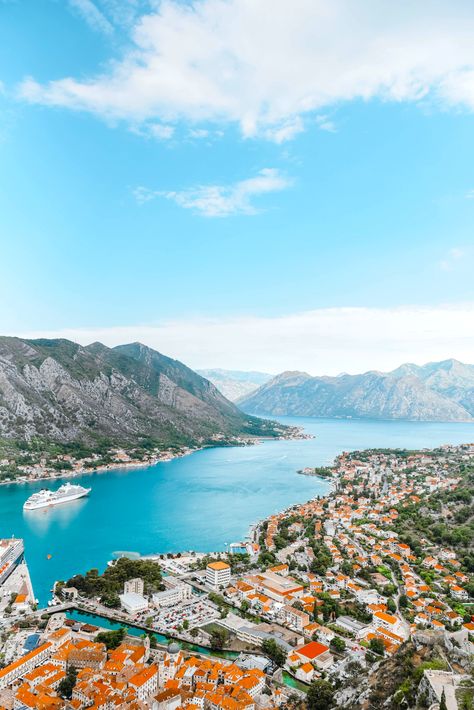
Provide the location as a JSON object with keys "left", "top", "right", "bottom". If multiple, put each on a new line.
{"left": 0, "top": 418, "right": 474, "bottom": 604}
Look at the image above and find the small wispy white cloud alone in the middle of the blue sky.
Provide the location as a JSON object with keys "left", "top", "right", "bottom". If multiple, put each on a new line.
{"left": 133, "top": 168, "right": 291, "bottom": 217}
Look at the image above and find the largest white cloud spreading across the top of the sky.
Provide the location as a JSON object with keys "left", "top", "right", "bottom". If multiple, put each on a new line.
{"left": 20, "top": 0, "right": 474, "bottom": 140}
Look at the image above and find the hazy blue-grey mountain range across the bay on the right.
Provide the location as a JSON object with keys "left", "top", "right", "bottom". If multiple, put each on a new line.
{"left": 237, "top": 360, "right": 474, "bottom": 421}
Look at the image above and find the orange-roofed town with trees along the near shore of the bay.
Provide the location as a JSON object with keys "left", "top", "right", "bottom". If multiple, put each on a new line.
{"left": 0, "top": 445, "right": 474, "bottom": 710}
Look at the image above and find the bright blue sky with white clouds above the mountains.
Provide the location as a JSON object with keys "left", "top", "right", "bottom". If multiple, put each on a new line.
{"left": 0, "top": 0, "right": 474, "bottom": 374}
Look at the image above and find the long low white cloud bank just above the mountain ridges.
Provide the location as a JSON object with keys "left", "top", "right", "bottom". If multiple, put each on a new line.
{"left": 16, "top": 304, "right": 474, "bottom": 375}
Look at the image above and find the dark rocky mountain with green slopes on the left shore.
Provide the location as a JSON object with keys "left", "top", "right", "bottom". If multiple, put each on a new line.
{"left": 0, "top": 337, "right": 282, "bottom": 445}
